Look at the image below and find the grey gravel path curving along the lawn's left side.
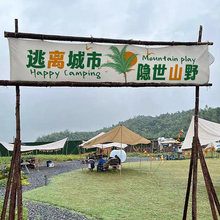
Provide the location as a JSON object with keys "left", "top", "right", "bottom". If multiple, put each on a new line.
{"left": 0, "top": 157, "right": 153, "bottom": 220}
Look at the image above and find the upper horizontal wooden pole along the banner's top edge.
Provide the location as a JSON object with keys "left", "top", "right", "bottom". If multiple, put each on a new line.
{"left": 5, "top": 32, "right": 213, "bottom": 46}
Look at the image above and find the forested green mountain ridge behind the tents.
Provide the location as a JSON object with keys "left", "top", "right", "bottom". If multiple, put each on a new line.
{"left": 36, "top": 106, "right": 220, "bottom": 142}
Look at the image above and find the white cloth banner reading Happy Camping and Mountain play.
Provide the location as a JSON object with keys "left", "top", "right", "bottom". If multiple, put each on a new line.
{"left": 8, "top": 38, "right": 209, "bottom": 85}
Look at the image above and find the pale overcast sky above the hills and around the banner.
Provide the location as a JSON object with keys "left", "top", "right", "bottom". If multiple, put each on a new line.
{"left": 0, "top": 0, "right": 220, "bottom": 141}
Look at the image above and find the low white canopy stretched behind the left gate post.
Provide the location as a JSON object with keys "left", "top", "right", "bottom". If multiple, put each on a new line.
{"left": 0, "top": 138, "right": 67, "bottom": 152}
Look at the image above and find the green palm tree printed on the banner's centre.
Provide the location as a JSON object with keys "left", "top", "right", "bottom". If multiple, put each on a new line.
{"left": 102, "top": 45, "right": 137, "bottom": 83}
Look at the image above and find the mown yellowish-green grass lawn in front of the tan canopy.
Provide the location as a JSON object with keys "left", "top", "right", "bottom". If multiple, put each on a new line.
{"left": 24, "top": 159, "right": 220, "bottom": 220}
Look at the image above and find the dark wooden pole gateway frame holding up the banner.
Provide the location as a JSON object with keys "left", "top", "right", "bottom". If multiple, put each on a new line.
{"left": 0, "top": 19, "right": 220, "bottom": 220}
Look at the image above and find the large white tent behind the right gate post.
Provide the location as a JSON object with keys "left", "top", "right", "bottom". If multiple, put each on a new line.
{"left": 182, "top": 117, "right": 220, "bottom": 150}
